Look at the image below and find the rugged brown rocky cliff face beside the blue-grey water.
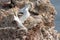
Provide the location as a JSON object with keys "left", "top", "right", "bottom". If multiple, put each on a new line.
{"left": 0, "top": 0, "right": 59, "bottom": 40}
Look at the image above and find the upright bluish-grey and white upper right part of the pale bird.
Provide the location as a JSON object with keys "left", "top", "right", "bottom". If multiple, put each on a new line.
{"left": 20, "top": 5, "right": 30, "bottom": 23}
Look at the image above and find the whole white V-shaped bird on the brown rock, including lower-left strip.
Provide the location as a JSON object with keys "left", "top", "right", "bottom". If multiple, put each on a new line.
{"left": 14, "top": 4, "right": 30, "bottom": 31}
